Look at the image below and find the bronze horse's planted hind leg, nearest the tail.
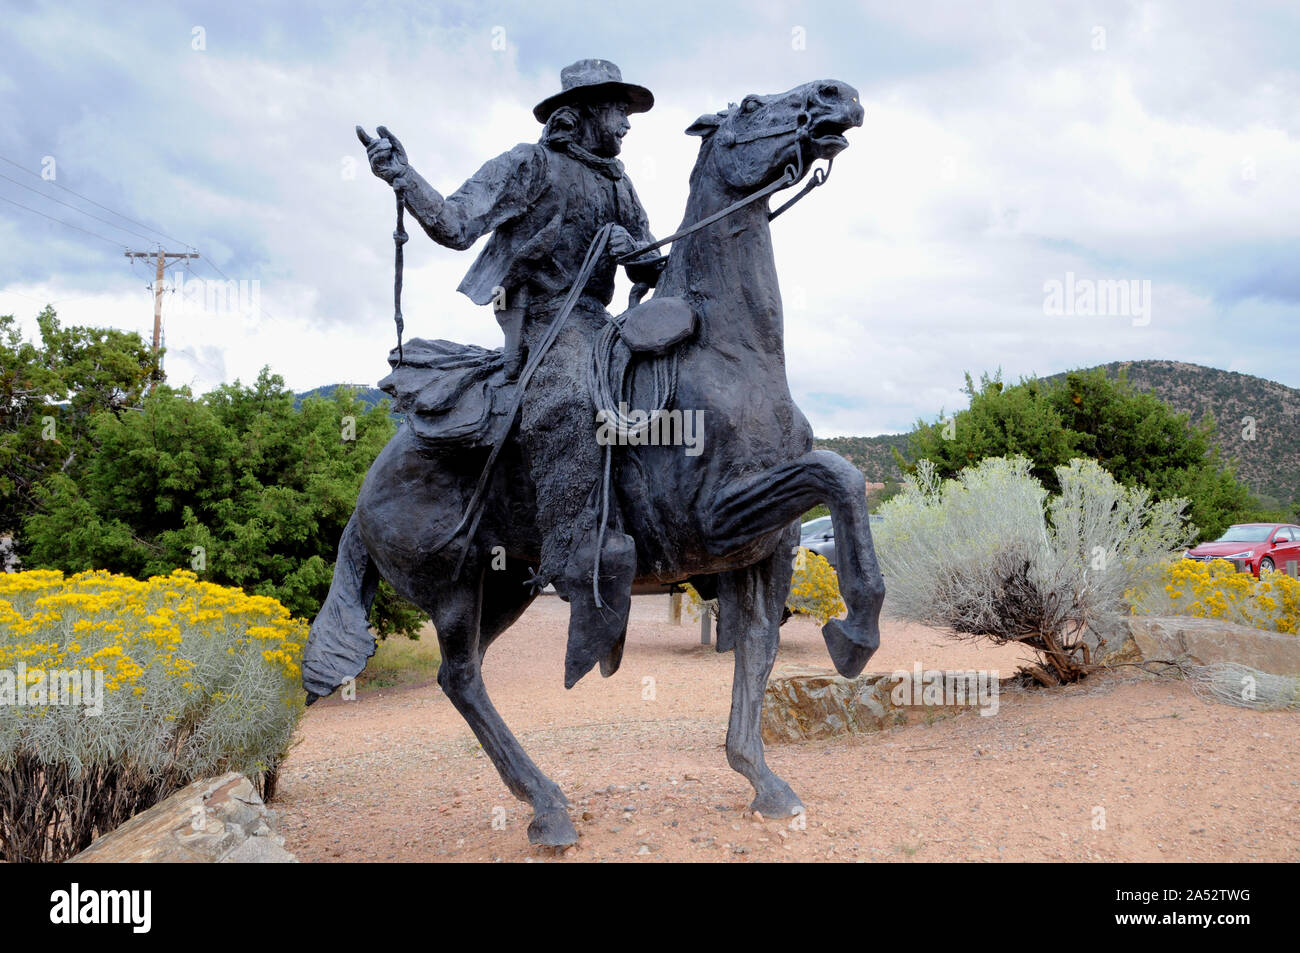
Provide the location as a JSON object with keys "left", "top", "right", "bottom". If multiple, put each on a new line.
{"left": 426, "top": 567, "right": 577, "bottom": 846}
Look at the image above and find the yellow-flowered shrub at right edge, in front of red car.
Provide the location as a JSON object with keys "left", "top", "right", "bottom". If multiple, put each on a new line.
{"left": 1128, "top": 559, "right": 1300, "bottom": 634}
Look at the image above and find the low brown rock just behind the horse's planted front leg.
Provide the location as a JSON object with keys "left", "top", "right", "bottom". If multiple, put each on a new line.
{"left": 761, "top": 667, "right": 1005, "bottom": 745}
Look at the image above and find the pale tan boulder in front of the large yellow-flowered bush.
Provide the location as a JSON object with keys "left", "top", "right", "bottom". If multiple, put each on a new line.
{"left": 69, "top": 772, "right": 296, "bottom": 863}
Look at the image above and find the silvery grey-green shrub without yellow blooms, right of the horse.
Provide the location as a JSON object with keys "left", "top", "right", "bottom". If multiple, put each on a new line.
{"left": 876, "top": 456, "right": 1195, "bottom": 684}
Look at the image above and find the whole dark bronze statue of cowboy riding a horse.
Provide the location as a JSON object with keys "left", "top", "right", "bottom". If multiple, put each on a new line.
{"left": 303, "top": 60, "right": 884, "bottom": 845}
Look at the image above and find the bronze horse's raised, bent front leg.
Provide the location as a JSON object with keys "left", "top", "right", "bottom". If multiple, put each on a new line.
{"left": 707, "top": 450, "right": 885, "bottom": 679}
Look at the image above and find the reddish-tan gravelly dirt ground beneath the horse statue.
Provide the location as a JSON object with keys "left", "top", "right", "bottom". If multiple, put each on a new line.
{"left": 274, "top": 597, "right": 1300, "bottom": 862}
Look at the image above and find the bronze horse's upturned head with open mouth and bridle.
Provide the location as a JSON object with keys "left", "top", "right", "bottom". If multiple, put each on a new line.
{"left": 686, "top": 79, "right": 863, "bottom": 195}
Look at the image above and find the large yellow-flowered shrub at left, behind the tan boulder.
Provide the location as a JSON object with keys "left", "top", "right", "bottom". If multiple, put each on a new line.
{"left": 0, "top": 569, "right": 307, "bottom": 859}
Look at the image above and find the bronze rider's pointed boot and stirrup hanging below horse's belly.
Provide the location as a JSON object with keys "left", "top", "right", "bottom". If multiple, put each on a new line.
{"left": 558, "top": 529, "right": 637, "bottom": 688}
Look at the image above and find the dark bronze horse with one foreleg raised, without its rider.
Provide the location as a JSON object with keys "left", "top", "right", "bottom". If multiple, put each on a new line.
{"left": 303, "top": 81, "right": 884, "bottom": 845}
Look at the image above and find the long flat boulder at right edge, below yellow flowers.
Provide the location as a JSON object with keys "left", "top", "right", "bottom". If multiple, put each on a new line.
{"left": 1095, "top": 615, "right": 1300, "bottom": 676}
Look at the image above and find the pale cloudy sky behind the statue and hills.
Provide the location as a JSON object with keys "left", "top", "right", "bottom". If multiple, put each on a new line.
{"left": 0, "top": 0, "right": 1300, "bottom": 436}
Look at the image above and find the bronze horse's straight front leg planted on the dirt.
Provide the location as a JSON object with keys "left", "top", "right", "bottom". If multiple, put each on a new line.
{"left": 718, "top": 529, "right": 803, "bottom": 818}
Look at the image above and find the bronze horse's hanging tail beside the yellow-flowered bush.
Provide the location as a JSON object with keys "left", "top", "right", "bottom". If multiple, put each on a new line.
{"left": 303, "top": 511, "right": 380, "bottom": 705}
